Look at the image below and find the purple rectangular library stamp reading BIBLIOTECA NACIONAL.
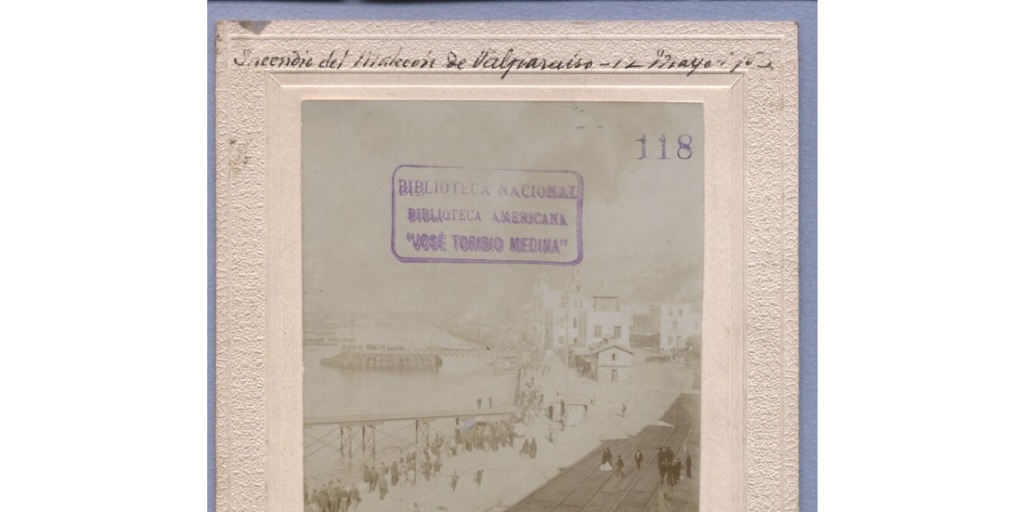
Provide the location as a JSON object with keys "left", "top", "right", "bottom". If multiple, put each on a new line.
{"left": 391, "top": 165, "right": 583, "bottom": 265}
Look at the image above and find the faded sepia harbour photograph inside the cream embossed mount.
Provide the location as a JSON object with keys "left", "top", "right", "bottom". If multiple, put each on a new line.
{"left": 301, "top": 100, "right": 705, "bottom": 512}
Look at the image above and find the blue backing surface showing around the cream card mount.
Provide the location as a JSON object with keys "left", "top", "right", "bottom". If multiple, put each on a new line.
{"left": 207, "top": 1, "right": 818, "bottom": 512}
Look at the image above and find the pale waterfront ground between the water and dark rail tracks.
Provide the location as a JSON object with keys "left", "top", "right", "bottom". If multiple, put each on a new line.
{"left": 307, "top": 356, "right": 699, "bottom": 512}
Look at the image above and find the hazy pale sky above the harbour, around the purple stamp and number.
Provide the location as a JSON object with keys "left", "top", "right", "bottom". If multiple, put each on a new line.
{"left": 302, "top": 101, "right": 703, "bottom": 327}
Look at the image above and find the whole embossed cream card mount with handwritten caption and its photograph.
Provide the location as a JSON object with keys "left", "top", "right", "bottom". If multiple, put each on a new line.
{"left": 214, "top": 19, "right": 800, "bottom": 512}
